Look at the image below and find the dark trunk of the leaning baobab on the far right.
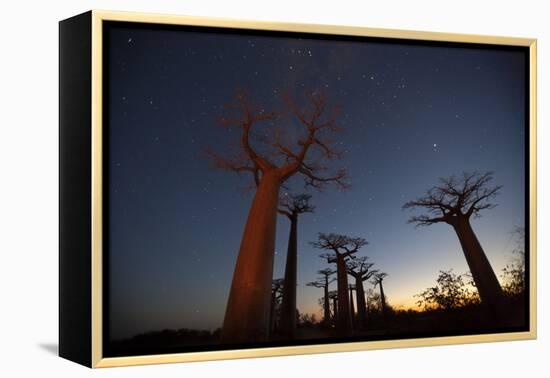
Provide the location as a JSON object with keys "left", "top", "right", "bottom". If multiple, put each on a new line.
{"left": 453, "top": 217, "right": 503, "bottom": 312}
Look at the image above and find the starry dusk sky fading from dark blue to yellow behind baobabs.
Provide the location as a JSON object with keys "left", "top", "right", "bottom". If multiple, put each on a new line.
{"left": 105, "top": 23, "right": 526, "bottom": 339}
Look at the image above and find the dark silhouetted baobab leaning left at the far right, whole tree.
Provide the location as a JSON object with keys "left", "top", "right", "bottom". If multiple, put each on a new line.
{"left": 403, "top": 172, "right": 503, "bottom": 314}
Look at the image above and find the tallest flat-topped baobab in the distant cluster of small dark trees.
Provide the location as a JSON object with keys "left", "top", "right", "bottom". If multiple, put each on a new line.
{"left": 310, "top": 232, "right": 367, "bottom": 333}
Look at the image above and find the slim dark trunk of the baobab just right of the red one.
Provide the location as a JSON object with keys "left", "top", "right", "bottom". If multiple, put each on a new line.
{"left": 281, "top": 216, "right": 298, "bottom": 337}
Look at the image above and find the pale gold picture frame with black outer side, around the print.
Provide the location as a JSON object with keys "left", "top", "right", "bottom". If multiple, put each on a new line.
{"left": 60, "top": 10, "right": 537, "bottom": 368}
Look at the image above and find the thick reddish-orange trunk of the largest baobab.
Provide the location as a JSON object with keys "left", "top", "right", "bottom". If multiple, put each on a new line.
{"left": 221, "top": 172, "right": 281, "bottom": 343}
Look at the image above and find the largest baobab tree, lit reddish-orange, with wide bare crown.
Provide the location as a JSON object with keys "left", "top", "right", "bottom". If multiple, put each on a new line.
{"left": 209, "top": 91, "right": 347, "bottom": 342}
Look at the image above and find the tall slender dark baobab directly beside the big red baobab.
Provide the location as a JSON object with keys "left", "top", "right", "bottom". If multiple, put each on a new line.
{"left": 279, "top": 194, "right": 315, "bottom": 337}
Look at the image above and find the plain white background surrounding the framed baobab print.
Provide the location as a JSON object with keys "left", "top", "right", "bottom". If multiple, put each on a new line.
{"left": 0, "top": 0, "right": 550, "bottom": 378}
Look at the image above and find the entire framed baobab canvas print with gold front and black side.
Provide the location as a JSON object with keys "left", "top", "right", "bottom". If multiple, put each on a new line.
{"left": 59, "top": 11, "right": 536, "bottom": 367}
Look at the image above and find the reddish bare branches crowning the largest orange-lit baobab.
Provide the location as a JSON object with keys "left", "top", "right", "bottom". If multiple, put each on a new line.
{"left": 208, "top": 91, "right": 350, "bottom": 190}
